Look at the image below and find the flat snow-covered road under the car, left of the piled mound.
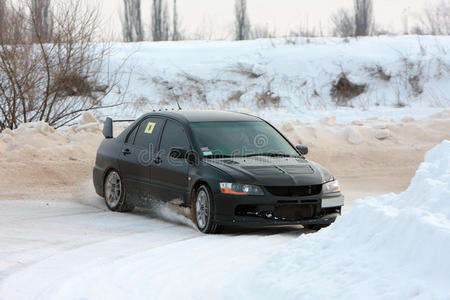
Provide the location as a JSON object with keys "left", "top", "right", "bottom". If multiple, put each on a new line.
{"left": 0, "top": 196, "right": 306, "bottom": 299}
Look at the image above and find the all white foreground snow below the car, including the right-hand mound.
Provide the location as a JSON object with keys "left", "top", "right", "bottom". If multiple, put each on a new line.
{"left": 0, "top": 141, "right": 450, "bottom": 299}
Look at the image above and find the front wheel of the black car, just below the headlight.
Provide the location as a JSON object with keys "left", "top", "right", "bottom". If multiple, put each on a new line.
{"left": 191, "top": 185, "right": 222, "bottom": 233}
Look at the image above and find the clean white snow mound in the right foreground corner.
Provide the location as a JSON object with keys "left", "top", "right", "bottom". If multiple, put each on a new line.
{"left": 232, "top": 141, "right": 450, "bottom": 299}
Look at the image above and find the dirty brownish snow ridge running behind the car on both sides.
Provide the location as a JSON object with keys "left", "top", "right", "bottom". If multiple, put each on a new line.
{"left": 0, "top": 110, "right": 450, "bottom": 163}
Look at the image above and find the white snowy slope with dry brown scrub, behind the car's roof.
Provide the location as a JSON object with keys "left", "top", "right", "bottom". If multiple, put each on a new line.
{"left": 101, "top": 36, "right": 450, "bottom": 122}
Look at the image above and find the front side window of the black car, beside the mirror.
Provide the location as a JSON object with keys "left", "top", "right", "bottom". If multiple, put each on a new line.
{"left": 159, "top": 120, "right": 190, "bottom": 155}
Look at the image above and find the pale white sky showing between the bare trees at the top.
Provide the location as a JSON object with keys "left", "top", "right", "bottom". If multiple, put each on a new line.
{"left": 97, "top": 0, "right": 432, "bottom": 38}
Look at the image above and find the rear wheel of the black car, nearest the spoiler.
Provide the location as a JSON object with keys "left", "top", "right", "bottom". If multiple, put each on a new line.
{"left": 103, "top": 170, "right": 134, "bottom": 212}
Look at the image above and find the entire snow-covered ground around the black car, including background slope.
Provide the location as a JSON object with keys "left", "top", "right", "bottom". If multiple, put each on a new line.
{"left": 0, "top": 36, "right": 450, "bottom": 300}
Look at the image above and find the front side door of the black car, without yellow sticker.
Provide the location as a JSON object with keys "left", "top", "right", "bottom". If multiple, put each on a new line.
{"left": 151, "top": 119, "right": 191, "bottom": 201}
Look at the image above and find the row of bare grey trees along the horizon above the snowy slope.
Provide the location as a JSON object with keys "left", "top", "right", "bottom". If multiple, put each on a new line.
{"left": 0, "top": 0, "right": 450, "bottom": 42}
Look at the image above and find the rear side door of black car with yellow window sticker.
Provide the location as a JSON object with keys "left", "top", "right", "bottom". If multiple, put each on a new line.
{"left": 119, "top": 117, "right": 164, "bottom": 202}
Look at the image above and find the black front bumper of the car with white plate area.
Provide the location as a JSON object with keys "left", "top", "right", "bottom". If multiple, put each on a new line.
{"left": 215, "top": 193, "right": 344, "bottom": 227}
